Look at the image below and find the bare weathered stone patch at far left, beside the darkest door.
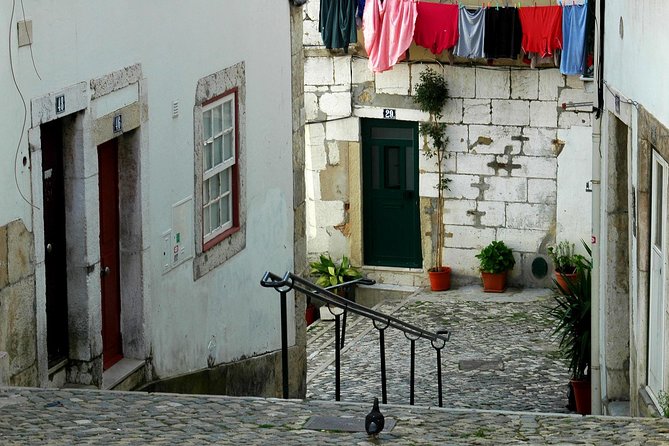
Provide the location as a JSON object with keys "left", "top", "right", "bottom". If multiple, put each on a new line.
{"left": 0, "top": 220, "right": 38, "bottom": 386}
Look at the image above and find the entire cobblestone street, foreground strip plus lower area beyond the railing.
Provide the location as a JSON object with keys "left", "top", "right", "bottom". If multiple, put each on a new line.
{"left": 0, "top": 287, "right": 669, "bottom": 446}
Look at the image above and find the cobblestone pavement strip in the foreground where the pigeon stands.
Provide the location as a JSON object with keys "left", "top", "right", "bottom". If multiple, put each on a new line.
{"left": 0, "top": 388, "right": 669, "bottom": 446}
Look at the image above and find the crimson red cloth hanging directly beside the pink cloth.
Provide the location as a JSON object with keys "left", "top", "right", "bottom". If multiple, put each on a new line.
{"left": 413, "top": 2, "right": 459, "bottom": 54}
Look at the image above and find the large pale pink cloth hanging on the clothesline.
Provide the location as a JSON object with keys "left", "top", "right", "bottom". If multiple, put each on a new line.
{"left": 362, "top": 0, "right": 416, "bottom": 72}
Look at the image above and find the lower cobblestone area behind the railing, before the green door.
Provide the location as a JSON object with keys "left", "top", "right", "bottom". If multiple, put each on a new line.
{"left": 307, "top": 286, "right": 569, "bottom": 413}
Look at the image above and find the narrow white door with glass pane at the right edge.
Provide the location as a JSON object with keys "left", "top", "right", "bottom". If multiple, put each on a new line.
{"left": 648, "top": 151, "right": 669, "bottom": 396}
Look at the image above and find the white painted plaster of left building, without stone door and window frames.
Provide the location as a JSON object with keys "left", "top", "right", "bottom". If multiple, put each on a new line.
{"left": 0, "top": 0, "right": 293, "bottom": 375}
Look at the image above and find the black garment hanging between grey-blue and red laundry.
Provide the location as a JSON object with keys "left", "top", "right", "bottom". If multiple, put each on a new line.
{"left": 483, "top": 8, "right": 523, "bottom": 59}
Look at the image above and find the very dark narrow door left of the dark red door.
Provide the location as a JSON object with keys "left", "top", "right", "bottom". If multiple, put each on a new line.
{"left": 40, "top": 120, "right": 68, "bottom": 367}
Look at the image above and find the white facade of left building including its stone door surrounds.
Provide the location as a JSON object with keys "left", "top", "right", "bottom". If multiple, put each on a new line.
{"left": 0, "top": 0, "right": 299, "bottom": 385}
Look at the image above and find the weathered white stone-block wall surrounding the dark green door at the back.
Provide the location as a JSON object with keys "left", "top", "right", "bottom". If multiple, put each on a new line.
{"left": 304, "top": 2, "right": 594, "bottom": 286}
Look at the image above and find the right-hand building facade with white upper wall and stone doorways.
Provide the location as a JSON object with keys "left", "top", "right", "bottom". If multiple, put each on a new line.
{"left": 593, "top": 0, "right": 669, "bottom": 415}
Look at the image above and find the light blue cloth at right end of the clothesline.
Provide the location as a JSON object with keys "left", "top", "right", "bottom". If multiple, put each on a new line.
{"left": 560, "top": 4, "right": 588, "bottom": 75}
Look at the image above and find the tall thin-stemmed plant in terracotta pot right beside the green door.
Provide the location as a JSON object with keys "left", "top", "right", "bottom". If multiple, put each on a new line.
{"left": 413, "top": 68, "right": 451, "bottom": 291}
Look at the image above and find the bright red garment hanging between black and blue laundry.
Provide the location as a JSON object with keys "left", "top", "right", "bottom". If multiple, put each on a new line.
{"left": 518, "top": 6, "right": 562, "bottom": 57}
